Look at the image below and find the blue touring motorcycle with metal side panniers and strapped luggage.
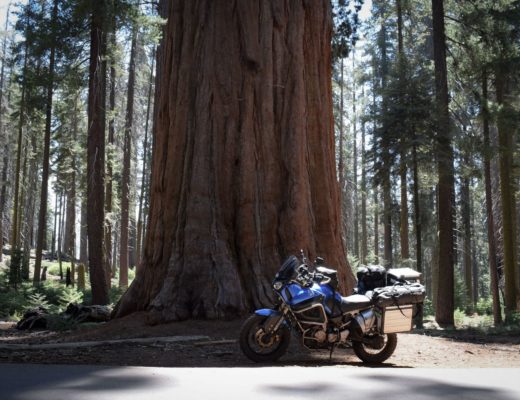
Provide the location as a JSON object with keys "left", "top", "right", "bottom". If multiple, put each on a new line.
{"left": 240, "top": 255, "right": 425, "bottom": 364}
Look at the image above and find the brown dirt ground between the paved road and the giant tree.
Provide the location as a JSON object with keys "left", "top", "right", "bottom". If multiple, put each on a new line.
{"left": 0, "top": 314, "right": 520, "bottom": 368}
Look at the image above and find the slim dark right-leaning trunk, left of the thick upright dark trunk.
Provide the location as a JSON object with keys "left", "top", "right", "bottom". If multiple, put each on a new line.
{"left": 33, "top": 0, "right": 58, "bottom": 286}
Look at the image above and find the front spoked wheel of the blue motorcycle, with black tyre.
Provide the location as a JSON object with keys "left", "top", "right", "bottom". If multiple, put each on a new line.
{"left": 240, "top": 314, "right": 291, "bottom": 362}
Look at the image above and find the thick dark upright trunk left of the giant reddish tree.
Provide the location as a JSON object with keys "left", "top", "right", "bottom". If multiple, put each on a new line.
{"left": 87, "top": 0, "right": 109, "bottom": 304}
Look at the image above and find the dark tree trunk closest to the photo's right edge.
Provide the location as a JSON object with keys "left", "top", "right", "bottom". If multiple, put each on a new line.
{"left": 495, "top": 65, "right": 517, "bottom": 320}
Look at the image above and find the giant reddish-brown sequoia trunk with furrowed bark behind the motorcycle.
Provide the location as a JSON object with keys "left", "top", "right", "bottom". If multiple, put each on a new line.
{"left": 116, "top": 0, "right": 354, "bottom": 320}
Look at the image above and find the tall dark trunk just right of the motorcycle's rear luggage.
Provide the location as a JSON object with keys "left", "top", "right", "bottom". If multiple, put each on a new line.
{"left": 432, "top": 0, "right": 455, "bottom": 326}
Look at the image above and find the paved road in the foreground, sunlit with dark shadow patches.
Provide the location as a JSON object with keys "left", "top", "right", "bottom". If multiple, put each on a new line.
{"left": 0, "top": 364, "right": 520, "bottom": 400}
